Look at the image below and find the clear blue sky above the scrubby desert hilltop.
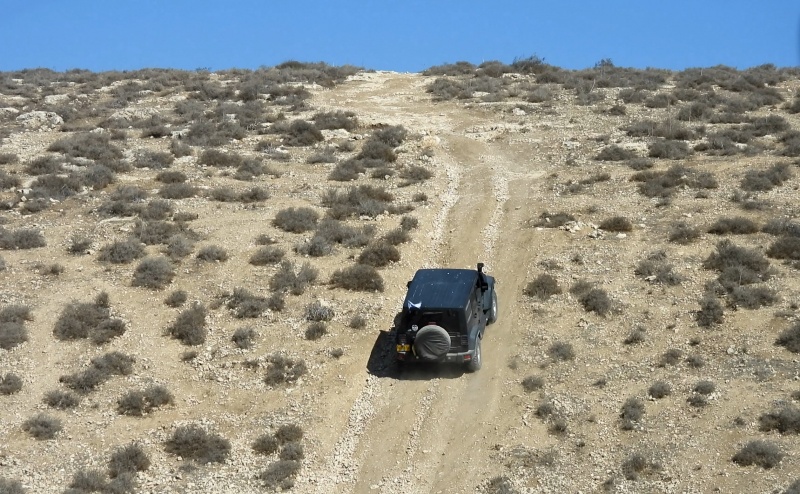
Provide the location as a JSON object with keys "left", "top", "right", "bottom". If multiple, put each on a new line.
{"left": 0, "top": 0, "right": 800, "bottom": 72}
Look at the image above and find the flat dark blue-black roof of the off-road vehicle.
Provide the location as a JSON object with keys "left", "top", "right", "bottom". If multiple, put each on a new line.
{"left": 403, "top": 268, "right": 478, "bottom": 310}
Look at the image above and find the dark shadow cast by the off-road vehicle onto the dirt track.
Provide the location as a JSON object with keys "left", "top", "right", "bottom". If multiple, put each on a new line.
{"left": 367, "top": 330, "right": 466, "bottom": 381}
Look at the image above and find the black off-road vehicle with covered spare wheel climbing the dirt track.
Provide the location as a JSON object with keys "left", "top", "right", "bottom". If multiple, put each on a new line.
{"left": 395, "top": 263, "right": 497, "bottom": 371}
